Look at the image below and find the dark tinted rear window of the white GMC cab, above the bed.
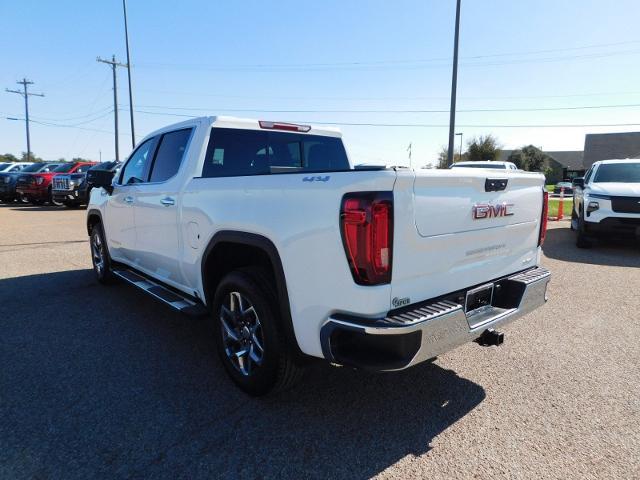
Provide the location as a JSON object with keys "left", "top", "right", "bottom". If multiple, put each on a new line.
{"left": 202, "top": 128, "right": 349, "bottom": 177}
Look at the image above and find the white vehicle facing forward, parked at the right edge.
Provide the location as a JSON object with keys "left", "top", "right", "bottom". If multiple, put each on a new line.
{"left": 571, "top": 160, "right": 640, "bottom": 248}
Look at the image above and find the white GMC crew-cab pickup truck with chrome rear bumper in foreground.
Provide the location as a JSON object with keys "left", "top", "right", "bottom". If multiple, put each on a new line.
{"left": 87, "top": 117, "right": 549, "bottom": 395}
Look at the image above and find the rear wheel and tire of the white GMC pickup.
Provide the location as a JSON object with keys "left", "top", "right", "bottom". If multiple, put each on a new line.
{"left": 211, "top": 268, "right": 303, "bottom": 396}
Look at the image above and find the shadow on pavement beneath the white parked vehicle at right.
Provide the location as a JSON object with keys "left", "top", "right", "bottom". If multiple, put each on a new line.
{"left": 542, "top": 225, "right": 640, "bottom": 268}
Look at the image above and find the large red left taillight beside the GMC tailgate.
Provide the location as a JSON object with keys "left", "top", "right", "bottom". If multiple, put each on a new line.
{"left": 340, "top": 192, "right": 393, "bottom": 285}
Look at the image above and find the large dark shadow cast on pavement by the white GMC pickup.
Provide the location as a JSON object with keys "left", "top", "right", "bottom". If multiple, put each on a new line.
{"left": 0, "top": 270, "right": 485, "bottom": 479}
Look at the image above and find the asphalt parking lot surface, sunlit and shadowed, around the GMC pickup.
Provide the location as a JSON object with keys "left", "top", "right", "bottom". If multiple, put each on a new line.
{"left": 0, "top": 205, "right": 640, "bottom": 479}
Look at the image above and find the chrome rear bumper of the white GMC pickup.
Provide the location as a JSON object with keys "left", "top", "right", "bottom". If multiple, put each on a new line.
{"left": 320, "top": 267, "right": 551, "bottom": 371}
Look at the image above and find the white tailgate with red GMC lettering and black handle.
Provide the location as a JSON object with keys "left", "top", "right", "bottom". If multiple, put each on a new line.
{"left": 391, "top": 169, "right": 544, "bottom": 307}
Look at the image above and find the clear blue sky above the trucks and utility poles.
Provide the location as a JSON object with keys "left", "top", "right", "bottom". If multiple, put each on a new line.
{"left": 0, "top": 0, "right": 640, "bottom": 165}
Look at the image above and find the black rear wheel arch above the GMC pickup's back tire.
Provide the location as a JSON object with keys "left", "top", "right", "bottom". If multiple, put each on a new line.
{"left": 201, "top": 230, "right": 303, "bottom": 358}
